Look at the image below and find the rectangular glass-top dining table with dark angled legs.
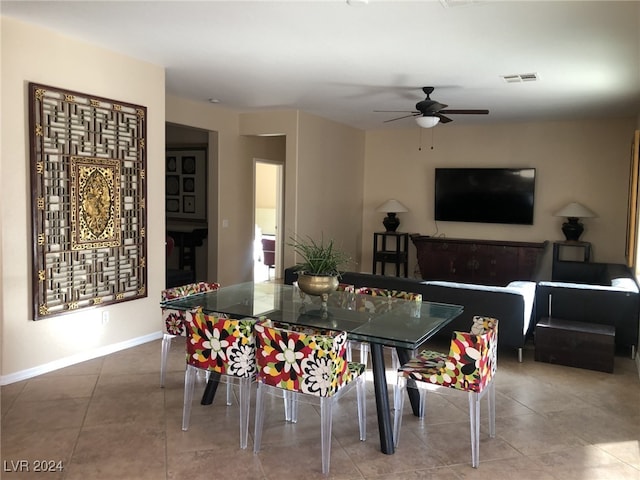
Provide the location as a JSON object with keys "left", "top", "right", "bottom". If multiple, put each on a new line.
{"left": 161, "top": 282, "right": 463, "bottom": 454}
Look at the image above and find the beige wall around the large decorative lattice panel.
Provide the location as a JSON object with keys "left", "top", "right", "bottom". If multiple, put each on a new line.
{"left": 0, "top": 18, "right": 165, "bottom": 382}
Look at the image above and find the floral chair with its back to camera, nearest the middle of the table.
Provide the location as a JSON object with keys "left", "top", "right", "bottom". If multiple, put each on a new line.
{"left": 253, "top": 321, "right": 366, "bottom": 474}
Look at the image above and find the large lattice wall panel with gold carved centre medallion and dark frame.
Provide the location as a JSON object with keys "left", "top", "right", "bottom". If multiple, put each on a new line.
{"left": 29, "top": 83, "right": 147, "bottom": 320}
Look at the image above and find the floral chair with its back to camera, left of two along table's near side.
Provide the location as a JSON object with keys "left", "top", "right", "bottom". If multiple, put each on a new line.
{"left": 182, "top": 309, "right": 256, "bottom": 448}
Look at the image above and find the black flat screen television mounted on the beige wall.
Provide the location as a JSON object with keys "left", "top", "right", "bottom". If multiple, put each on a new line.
{"left": 435, "top": 168, "right": 536, "bottom": 225}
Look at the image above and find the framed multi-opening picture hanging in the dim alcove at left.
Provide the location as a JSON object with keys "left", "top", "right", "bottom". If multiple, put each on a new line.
{"left": 165, "top": 148, "right": 207, "bottom": 221}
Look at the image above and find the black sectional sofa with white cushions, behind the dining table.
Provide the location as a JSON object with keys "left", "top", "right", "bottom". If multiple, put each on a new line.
{"left": 284, "top": 262, "right": 640, "bottom": 361}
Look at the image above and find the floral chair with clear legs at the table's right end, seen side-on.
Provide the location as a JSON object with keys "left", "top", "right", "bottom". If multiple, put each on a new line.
{"left": 393, "top": 316, "right": 498, "bottom": 468}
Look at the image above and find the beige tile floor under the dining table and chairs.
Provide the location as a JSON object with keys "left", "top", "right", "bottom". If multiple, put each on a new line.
{"left": 0, "top": 339, "right": 640, "bottom": 480}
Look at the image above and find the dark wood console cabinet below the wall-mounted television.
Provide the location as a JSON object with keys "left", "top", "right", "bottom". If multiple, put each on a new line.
{"left": 411, "top": 235, "right": 547, "bottom": 286}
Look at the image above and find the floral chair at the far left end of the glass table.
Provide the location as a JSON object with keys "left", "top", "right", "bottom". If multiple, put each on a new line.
{"left": 160, "top": 282, "right": 220, "bottom": 387}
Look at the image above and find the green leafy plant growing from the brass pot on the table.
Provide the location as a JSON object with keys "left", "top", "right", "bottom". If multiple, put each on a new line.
{"left": 289, "top": 237, "right": 350, "bottom": 277}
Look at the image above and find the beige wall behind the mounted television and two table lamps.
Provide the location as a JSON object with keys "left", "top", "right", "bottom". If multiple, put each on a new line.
{"left": 362, "top": 118, "right": 636, "bottom": 272}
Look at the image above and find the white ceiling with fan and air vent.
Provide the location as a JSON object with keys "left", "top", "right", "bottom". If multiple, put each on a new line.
{"left": 0, "top": 0, "right": 640, "bottom": 129}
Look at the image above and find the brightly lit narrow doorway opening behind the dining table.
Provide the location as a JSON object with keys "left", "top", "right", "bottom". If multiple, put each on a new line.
{"left": 253, "top": 159, "right": 283, "bottom": 282}
